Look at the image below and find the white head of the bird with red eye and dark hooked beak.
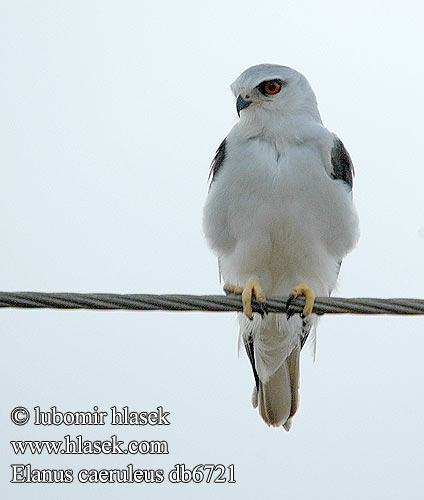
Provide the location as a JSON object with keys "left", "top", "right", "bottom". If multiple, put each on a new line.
{"left": 231, "top": 64, "right": 320, "bottom": 122}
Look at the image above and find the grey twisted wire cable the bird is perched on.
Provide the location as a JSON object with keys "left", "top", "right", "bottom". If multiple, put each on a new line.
{"left": 0, "top": 292, "right": 424, "bottom": 315}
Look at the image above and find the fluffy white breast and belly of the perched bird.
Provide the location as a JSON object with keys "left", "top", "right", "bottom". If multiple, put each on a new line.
{"left": 204, "top": 131, "right": 357, "bottom": 294}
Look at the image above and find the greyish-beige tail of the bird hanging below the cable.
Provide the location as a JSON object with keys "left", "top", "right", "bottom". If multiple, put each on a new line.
{"left": 258, "top": 346, "right": 300, "bottom": 431}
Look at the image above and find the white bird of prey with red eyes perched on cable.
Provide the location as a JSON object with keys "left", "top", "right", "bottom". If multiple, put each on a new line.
{"left": 203, "top": 64, "right": 359, "bottom": 431}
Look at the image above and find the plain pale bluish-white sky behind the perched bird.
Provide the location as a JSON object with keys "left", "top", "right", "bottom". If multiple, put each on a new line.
{"left": 0, "top": 0, "right": 424, "bottom": 500}
